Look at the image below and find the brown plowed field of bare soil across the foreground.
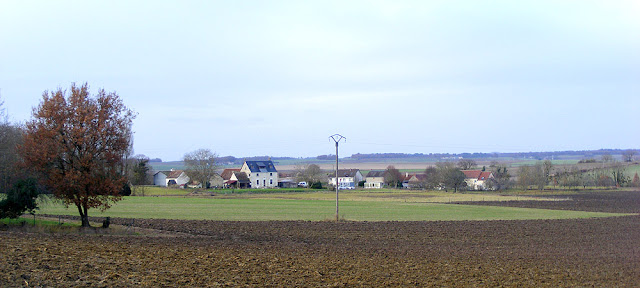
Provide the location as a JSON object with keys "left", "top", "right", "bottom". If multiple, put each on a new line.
{"left": 0, "top": 190, "right": 640, "bottom": 287}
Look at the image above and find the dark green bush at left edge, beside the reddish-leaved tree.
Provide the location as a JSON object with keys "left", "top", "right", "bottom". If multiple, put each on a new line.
{"left": 0, "top": 179, "right": 39, "bottom": 219}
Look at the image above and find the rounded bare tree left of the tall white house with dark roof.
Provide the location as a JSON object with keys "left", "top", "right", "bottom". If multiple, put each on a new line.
{"left": 182, "top": 149, "right": 219, "bottom": 188}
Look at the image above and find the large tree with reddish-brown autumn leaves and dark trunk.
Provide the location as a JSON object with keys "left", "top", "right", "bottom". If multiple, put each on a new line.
{"left": 20, "top": 83, "right": 135, "bottom": 225}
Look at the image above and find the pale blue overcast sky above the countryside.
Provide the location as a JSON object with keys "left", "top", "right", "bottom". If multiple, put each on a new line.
{"left": 0, "top": 0, "right": 640, "bottom": 161}
